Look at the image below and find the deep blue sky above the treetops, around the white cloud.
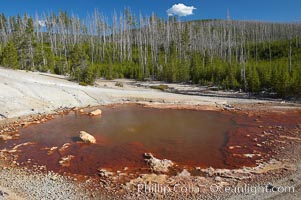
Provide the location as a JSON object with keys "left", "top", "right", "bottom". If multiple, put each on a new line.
{"left": 0, "top": 0, "right": 301, "bottom": 22}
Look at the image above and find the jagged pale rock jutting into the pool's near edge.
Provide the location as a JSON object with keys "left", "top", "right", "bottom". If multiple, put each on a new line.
{"left": 144, "top": 153, "right": 174, "bottom": 172}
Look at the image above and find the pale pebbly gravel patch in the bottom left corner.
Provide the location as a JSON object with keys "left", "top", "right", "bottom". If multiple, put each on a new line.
{"left": 0, "top": 165, "right": 101, "bottom": 200}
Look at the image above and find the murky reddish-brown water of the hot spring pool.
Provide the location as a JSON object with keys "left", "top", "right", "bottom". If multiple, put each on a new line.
{"left": 5, "top": 105, "right": 236, "bottom": 175}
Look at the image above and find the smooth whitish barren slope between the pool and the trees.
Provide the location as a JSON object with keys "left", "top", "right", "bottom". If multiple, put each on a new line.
{"left": 0, "top": 68, "right": 274, "bottom": 118}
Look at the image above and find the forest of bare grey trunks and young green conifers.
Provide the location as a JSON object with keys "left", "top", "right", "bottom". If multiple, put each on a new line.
{"left": 0, "top": 9, "right": 301, "bottom": 97}
